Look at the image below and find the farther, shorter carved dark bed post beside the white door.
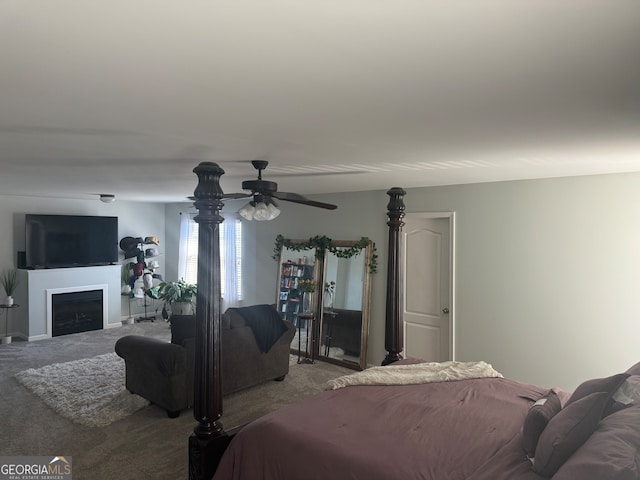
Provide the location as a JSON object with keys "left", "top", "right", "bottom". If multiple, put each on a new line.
{"left": 382, "top": 187, "right": 407, "bottom": 365}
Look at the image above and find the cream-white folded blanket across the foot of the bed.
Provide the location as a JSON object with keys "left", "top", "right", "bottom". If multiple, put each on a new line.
{"left": 324, "top": 361, "right": 502, "bottom": 390}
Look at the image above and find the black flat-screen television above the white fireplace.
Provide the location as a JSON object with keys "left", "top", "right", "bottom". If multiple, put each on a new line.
{"left": 25, "top": 214, "right": 118, "bottom": 268}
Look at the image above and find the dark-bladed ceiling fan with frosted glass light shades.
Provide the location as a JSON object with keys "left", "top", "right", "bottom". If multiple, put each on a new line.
{"left": 224, "top": 160, "right": 338, "bottom": 220}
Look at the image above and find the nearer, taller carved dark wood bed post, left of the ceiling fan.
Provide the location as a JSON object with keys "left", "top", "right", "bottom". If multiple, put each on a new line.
{"left": 189, "top": 162, "right": 225, "bottom": 480}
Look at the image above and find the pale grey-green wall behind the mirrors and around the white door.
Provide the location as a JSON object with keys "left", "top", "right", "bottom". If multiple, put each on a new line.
{"left": 239, "top": 174, "right": 640, "bottom": 390}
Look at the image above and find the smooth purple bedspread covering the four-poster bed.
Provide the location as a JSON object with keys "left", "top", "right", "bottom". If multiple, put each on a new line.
{"left": 214, "top": 378, "right": 546, "bottom": 480}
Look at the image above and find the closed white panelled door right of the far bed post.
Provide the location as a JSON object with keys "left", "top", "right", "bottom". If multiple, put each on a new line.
{"left": 402, "top": 214, "right": 453, "bottom": 362}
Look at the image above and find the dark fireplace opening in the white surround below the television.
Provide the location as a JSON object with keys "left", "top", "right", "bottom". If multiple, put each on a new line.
{"left": 51, "top": 290, "right": 103, "bottom": 337}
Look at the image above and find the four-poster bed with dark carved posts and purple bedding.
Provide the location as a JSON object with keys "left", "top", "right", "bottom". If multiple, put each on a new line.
{"left": 189, "top": 164, "right": 640, "bottom": 480}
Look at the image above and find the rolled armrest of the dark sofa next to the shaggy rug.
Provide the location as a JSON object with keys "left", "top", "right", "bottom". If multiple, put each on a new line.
{"left": 115, "top": 335, "right": 187, "bottom": 376}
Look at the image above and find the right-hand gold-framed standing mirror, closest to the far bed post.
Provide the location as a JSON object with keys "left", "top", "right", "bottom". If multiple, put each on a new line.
{"left": 318, "top": 241, "right": 373, "bottom": 370}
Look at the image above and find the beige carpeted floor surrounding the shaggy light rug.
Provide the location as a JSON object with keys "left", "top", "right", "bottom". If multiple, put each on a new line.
{"left": 0, "top": 322, "right": 352, "bottom": 480}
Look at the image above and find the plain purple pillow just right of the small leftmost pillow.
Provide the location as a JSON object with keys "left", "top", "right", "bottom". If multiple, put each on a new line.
{"left": 533, "top": 392, "right": 611, "bottom": 477}
